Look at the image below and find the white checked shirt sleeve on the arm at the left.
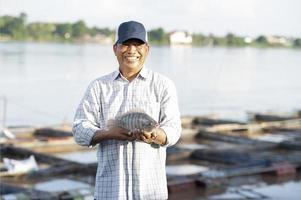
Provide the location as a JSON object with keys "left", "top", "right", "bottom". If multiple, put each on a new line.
{"left": 72, "top": 82, "right": 101, "bottom": 146}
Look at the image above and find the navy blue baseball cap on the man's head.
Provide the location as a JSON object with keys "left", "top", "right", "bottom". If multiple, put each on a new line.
{"left": 116, "top": 21, "right": 147, "bottom": 44}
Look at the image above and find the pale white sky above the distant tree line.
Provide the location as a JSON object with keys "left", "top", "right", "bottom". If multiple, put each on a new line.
{"left": 0, "top": 0, "right": 301, "bottom": 38}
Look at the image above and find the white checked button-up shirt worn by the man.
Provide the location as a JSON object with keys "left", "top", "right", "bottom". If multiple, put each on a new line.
{"left": 73, "top": 67, "right": 181, "bottom": 200}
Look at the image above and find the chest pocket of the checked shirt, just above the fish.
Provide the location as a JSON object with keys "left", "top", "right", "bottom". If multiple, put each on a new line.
{"left": 133, "top": 100, "right": 160, "bottom": 122}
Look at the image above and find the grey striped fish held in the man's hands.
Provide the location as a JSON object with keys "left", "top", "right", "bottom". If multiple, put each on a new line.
{"left": 108, "top": 111, "right": 159, "bottom": 134}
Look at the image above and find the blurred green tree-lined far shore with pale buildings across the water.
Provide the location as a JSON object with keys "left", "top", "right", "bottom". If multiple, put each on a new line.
{"left": 0, "top": 13, "right": 301, "bottom": 48}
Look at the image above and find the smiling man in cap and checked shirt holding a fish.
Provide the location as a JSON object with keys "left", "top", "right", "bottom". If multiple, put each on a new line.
{"left": 73, "top": 21, "right": 181, "bottom": 200}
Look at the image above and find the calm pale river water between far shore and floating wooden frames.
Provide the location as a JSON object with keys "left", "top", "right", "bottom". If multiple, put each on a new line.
{"left": 0, "top": 42, "right": 301, "bottom": 126}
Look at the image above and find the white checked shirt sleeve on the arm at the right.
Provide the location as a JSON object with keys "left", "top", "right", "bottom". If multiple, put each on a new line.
{"left": 160, "top": 80, "right": 182, "bottom": 147}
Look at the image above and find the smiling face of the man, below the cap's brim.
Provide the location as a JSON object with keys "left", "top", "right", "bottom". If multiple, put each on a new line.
{"left": 113, "top": 39, "right": 149, "bottom": 69}
